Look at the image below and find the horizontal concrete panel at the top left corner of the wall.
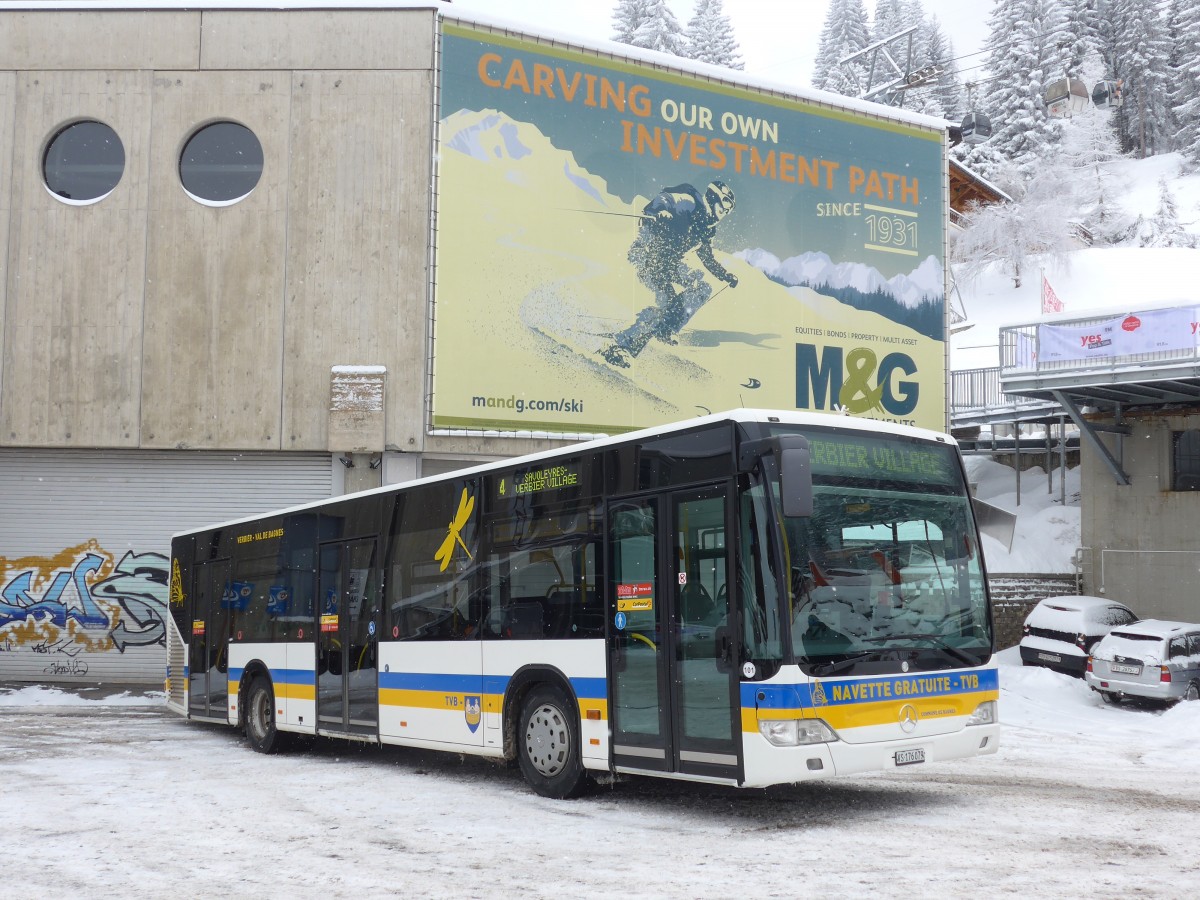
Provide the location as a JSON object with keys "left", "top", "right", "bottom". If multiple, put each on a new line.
{"left": 0, "top": 10, "right": 200, "bottom": 71}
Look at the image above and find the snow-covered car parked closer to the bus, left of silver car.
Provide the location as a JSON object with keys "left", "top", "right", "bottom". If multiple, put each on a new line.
{"left": 1021, "top": 595, "right": 1138, "bottom": 678}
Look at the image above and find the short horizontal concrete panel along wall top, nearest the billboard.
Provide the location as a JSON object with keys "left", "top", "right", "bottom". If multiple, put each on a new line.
{"left": 200, "top": 10, "right": 434, "bottom": 70}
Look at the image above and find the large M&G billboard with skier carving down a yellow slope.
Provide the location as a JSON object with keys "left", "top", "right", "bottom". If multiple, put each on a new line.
{"left": 432, "top": 20, "right": 947, "bottom": 433}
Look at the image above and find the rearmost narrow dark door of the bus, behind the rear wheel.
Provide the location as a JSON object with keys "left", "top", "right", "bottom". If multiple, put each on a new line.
{"left": 187, "top": 559, "right": 233, "bottom": 722}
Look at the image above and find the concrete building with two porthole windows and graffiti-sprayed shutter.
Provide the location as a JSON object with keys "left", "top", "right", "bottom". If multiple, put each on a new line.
{"left": 0, "top": 4, "right": 562, "bottom": 680}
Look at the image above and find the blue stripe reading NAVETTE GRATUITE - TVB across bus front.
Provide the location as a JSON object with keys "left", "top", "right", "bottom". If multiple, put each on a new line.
{"left": 742, "top": 668, "right": 1000, "bottom": 709}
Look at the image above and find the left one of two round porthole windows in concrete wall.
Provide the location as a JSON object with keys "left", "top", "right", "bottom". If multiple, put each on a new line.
{"left": 42, "top": 121, "right": 125, "bottom": 206}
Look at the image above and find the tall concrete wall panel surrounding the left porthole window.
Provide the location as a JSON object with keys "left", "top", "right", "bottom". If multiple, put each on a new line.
{"left": 0, "top": 72, "right": 151, "bottom": 446}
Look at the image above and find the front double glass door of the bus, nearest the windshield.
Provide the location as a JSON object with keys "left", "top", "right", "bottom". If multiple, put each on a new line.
{"left": 608, "top": 486, "right": 742, "bottom": 780}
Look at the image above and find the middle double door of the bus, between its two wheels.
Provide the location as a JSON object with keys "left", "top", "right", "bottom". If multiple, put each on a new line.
{"left": 317, "top": 538, "right": 379, "bottom": 736}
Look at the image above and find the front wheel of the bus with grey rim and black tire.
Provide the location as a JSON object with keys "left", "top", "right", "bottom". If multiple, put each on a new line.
{"left": 517, "top": 684, "right": 588, "bottom": 800}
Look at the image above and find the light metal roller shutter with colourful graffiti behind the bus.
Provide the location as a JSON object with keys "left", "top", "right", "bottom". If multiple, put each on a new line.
{"left": 0, "top": 449, "right": 334, "bottom": 684}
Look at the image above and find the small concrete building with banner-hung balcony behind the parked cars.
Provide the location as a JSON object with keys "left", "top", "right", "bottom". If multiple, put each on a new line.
{"left": 1000, "top": 305, "right": 1200, "bottom": 622}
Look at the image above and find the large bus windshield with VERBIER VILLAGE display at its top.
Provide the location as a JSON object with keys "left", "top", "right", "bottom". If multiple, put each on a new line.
{"left": 781, "top": 432, "right": 992, "bottom": 676}
